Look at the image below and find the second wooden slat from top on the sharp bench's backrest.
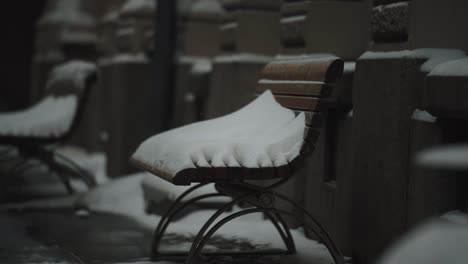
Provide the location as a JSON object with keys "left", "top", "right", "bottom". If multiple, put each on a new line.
{"left": 257, "top": 81, "right": 331, "bottom": 97}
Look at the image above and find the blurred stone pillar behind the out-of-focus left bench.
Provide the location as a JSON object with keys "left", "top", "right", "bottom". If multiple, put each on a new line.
{"left": 32, "top": 0, "right": 100, "bottom": 151}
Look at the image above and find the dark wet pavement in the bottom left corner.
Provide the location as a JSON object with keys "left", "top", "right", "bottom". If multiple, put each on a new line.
{"left": 0, "top": 210, "right": 151, "bottom": 264}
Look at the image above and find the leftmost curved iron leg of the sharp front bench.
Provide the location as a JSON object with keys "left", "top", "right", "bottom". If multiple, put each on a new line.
{"left": 151, "top": 193, "right": 226, "bottom": 260}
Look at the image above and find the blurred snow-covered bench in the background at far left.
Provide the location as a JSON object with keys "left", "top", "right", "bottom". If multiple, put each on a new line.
{"left": 0, "top": 61, "right": 97, "bottom": 193}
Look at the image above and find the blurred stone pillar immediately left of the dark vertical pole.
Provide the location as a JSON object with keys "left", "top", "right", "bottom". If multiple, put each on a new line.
{"left": 99, "top": 0, "right": 156, "bottom": 177}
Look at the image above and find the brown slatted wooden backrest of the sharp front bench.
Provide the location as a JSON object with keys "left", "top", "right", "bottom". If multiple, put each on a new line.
{"left": 256, "top": 56, "right": 344, "bottom": 154}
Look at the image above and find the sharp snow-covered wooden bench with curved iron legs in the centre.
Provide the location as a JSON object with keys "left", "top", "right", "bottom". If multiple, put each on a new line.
{"left": 130, "top": 55, "right": 344, "bottom": 263}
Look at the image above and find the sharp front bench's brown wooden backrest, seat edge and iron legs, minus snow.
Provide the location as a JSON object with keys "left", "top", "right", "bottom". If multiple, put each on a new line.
{"left": 130, "top": 57, "right": 345, "bottom": 264}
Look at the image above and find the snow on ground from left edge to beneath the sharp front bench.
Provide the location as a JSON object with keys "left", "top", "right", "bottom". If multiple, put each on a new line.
{"left": 0, "top": 148, "right": 332, "bottom": 264}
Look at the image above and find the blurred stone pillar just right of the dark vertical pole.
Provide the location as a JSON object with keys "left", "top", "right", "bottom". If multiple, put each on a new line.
{"left": 171, "top": 0, "right": 224, "bottom": 127}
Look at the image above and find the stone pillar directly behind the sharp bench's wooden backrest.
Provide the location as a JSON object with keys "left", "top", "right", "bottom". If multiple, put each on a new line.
{"left": 281, "top": 0, "right": 370, "bottom": 255}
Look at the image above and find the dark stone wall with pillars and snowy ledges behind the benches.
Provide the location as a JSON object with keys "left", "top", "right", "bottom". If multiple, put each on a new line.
{"left": 0, "top": 0, "right": 468, "bottom": 263}
